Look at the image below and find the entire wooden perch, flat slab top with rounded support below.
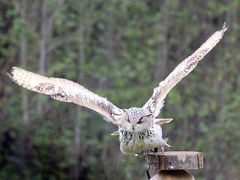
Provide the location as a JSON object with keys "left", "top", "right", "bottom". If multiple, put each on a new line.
{"left": 146, "top": 151, "right": 203, "bottom": 180}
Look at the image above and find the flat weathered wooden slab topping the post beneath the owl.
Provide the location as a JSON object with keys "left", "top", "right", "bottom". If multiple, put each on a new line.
{"left": 146, "top": 151, "right": 203, "bottom": 170}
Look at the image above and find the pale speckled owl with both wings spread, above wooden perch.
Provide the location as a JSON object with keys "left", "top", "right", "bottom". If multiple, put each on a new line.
{"left": 8, "top": 24, "right": 227, "bottom": 154}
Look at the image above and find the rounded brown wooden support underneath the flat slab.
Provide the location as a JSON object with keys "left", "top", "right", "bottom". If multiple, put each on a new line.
{"left": 150, "top": 170, "right": 195, "bottom": 180}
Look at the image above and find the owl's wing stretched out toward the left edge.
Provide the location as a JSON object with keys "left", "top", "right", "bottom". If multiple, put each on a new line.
{"left": 8, "top": 67, "right": 122, "bottom": 124}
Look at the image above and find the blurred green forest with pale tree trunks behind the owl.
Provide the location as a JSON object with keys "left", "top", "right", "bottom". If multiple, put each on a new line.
{"left": 0, "top": 0, "right": 240, "bottom": 180}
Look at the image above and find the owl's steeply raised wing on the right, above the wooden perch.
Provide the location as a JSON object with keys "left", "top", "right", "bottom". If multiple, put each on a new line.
{"left": 143, "top": 23, "right": 227, "bottom": 117}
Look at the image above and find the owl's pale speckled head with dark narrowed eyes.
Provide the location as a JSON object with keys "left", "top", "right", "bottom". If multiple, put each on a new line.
{"left": 117, "top": 107, "right": 153, "bottom": 132}
